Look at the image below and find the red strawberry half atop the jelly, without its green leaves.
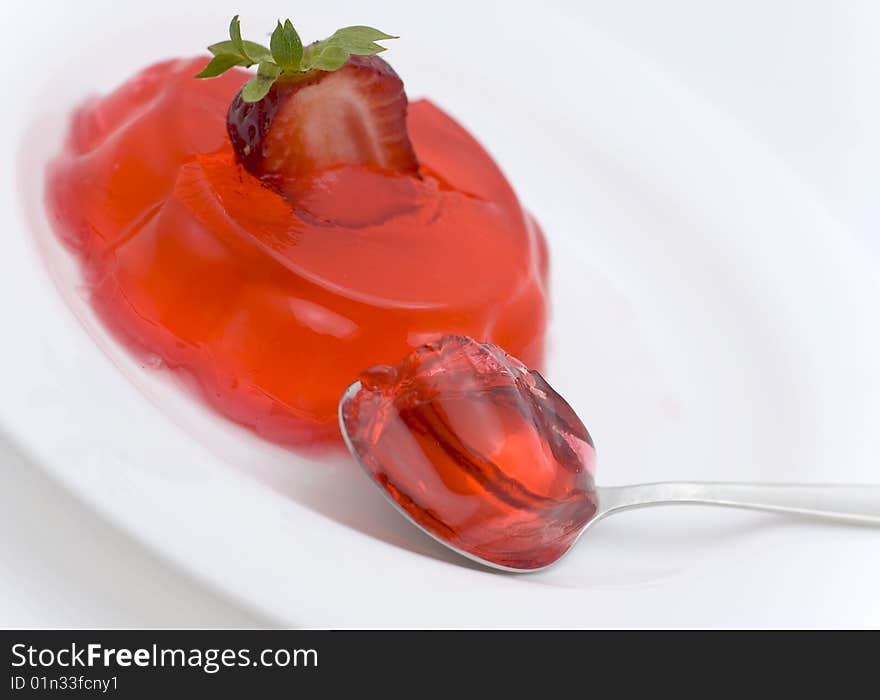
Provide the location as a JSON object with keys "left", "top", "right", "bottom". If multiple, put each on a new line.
{"left": 226, "top": 56, "right": 419, "bottom": 181}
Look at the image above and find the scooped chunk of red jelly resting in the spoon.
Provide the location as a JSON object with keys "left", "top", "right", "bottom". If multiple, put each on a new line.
{"left": 340, "top": 336, "right": 597, "bottom": 569}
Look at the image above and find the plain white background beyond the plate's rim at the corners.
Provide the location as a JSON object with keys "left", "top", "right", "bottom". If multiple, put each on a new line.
{"left": 0, "top": 0, "right": 880, "bottom": 626}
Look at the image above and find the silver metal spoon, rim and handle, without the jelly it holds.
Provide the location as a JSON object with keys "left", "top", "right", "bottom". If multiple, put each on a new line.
{"left": 339, "top": 382, "right": 880, "bottom": 573}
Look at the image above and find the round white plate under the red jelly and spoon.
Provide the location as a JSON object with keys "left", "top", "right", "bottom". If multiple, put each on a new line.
{"left": 0, "top": 3, "right": 880, "bottom": 626}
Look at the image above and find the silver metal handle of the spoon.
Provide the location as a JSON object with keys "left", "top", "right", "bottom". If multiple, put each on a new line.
{"left": 597, "top": 482, "right": 880, "bottom": 525}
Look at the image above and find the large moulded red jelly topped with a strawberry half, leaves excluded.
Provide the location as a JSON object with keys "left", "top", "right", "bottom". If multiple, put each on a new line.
{"left": 48, "top": 21, "right": 547, "bottom": 445}
